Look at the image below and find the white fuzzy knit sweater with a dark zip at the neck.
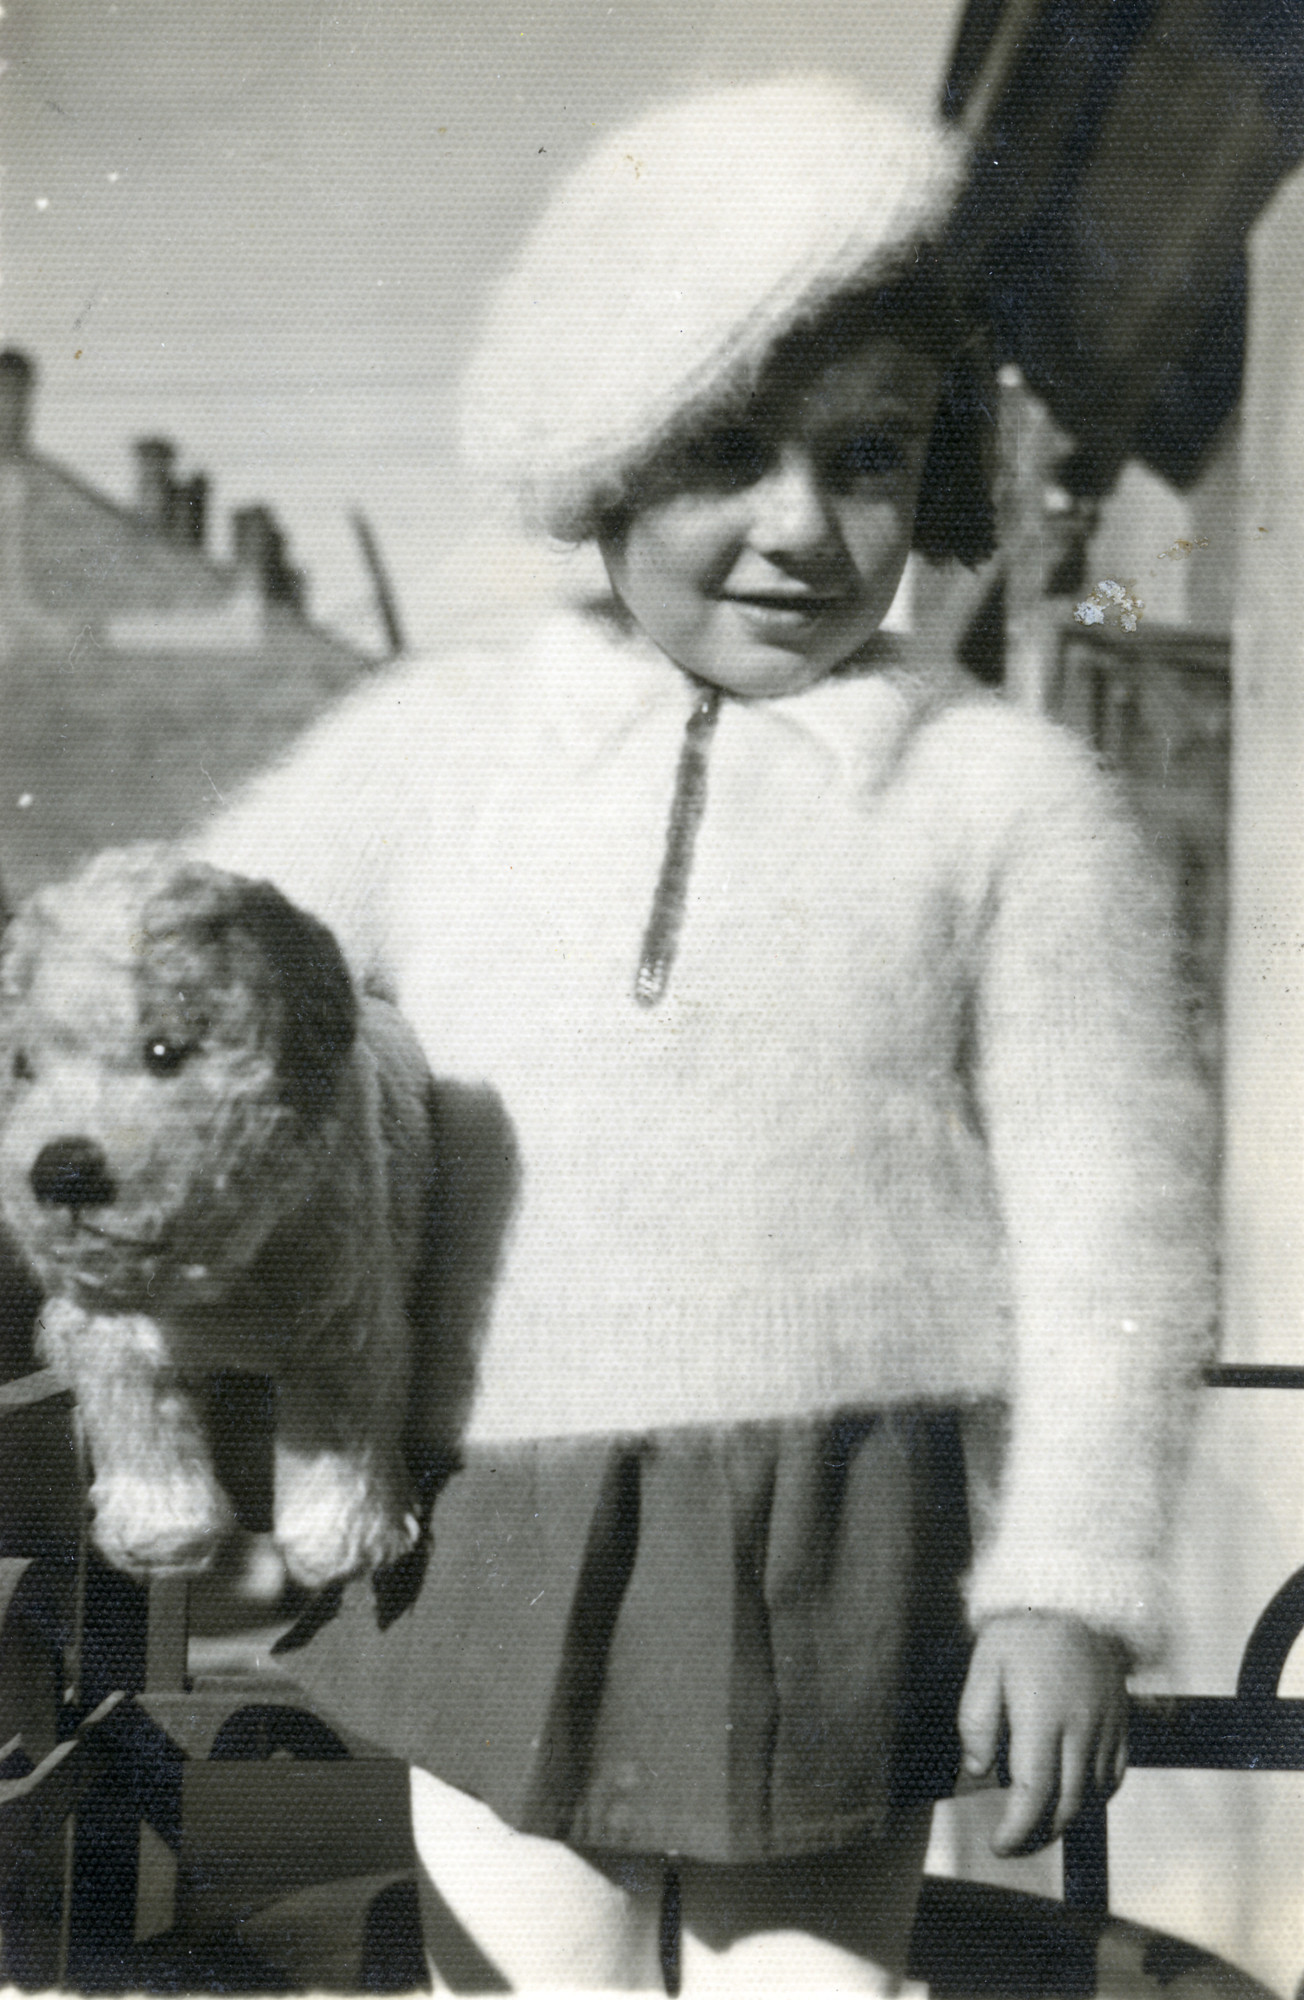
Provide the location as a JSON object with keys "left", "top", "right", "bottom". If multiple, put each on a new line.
{"left": 194, "top": 614, "right": 1210, "bottom": 1652}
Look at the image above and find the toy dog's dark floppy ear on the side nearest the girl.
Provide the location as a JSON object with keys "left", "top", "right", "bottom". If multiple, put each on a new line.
{"left": 144, "top": 862, "right": 358, "bottom": 1118}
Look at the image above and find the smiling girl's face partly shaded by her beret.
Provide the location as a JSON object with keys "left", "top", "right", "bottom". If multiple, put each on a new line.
{"left": 600, "top": 334, "right": 940, "bottom": 696}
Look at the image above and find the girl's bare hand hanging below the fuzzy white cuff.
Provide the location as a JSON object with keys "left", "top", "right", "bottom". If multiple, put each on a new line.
{"left": 960, "top": 1612, "right": 1128, "bottom": 1854}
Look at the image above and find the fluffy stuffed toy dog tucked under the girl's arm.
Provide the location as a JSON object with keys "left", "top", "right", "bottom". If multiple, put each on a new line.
{"left": 0, "top": 848, "right": 432, "bottom": 1586}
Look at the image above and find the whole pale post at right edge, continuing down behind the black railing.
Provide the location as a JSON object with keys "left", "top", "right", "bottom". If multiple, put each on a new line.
{"left": 1186, "top": 174, "right": 1304, "bottom": 1992}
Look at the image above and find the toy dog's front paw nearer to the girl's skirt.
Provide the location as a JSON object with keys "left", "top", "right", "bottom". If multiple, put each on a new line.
{"left": 274, "top": 1446, "right": 420, "bottom": 1590}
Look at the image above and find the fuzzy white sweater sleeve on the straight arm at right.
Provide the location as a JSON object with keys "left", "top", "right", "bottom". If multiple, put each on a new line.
{"left": 968, "top": 714, "right": 1212, "bottom": 1658}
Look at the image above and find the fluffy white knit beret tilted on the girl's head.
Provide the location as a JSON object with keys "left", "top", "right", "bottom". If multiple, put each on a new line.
{"left": 462, "top": 76, "right": 964, "bottom": 538}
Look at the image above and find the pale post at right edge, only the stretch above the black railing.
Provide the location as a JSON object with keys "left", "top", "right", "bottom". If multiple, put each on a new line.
{"left": 1224, "top": 174, "right": 1304, "bottom": 1368}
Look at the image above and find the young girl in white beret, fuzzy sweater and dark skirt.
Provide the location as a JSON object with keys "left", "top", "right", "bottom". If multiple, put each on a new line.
{"left": 196, "top": 80, "right": 1208, "bottom": 1992}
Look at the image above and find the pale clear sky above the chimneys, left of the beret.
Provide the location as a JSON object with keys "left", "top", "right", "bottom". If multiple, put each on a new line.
{"left": 0, "top": 0, "right": 960, "bottom": 644}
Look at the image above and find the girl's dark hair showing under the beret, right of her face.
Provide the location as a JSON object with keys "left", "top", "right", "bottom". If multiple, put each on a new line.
{"left": 770, "top": 244, "right": 996, "bottom": 568}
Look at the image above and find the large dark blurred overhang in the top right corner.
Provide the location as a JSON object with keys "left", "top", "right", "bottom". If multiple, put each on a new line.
{"left": 942, "top": 0, "right": 1304, "bottom": 494}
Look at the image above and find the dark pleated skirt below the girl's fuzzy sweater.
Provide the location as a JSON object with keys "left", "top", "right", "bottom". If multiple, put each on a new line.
{"left": 272, "top": 1412, "right": 968, "bottom": 1862}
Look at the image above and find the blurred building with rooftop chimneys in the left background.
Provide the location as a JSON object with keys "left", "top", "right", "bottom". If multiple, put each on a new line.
{"left": 0, "top": 350, "right": 374, "bottom": 896}
